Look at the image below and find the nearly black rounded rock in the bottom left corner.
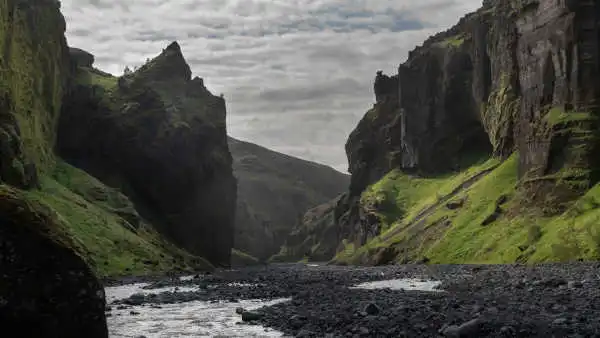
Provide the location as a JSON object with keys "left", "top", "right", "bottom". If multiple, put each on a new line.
{"left": 0, "top": 187, "right": 108, "bottom": 338}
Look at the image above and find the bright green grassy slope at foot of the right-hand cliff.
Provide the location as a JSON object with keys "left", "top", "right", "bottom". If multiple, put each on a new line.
{"left": 336, "top": 154, "right": 600, "bottom": 264}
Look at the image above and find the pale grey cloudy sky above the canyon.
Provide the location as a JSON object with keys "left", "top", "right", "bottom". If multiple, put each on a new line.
{"left": 62, "top": 0, "right": 481, "bottom": 171}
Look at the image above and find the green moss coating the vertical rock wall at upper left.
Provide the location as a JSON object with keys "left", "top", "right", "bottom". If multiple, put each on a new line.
{"left": 0, "top": 0, "right": 66, "bottom": 172}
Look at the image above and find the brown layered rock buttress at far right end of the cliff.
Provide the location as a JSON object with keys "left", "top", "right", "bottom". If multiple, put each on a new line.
{"left": 515, "top": 0, "right": 600, "bottom": 211}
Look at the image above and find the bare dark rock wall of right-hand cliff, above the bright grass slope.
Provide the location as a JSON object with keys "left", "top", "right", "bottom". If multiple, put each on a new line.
{"left": 296, "top": 0, "right": 600, "bottom": 262}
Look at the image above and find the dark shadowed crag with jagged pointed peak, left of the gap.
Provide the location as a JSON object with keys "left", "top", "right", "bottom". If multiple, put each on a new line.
{"left": 58, "top": 42, "right": 236, "bottom": 266}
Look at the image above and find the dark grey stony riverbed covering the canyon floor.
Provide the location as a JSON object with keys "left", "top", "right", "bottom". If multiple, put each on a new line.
{"left": 109, "top": 263, "right": 600, "bottom": 338}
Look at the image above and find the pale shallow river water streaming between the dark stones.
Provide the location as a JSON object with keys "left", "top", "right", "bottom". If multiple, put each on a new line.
{"left": 106, "top": 277, "right": 439, "bottom": 338}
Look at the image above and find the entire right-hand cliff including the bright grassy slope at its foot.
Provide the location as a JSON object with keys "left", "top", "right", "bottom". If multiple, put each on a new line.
{"left": 288, "top": 0, "right": 600, "bottom": 263}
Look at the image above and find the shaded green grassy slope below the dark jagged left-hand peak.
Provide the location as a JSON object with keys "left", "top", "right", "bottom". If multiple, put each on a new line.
{"left": 27, "top": 163, "right": 210, "bottom": 276}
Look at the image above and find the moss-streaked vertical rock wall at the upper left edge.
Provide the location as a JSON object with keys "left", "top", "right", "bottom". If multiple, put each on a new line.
{"left": 0, "top": 0, "right": 69, "bottom": 188}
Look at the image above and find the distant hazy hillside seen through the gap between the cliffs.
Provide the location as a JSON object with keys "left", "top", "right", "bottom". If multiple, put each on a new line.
{"left": 229, "top": 137, "right": 350, "bottom": 259}
